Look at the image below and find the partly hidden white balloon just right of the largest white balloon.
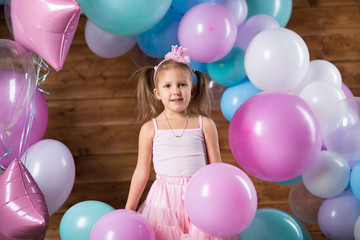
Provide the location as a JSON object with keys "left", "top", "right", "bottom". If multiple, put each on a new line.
{"left": 290, "top": 60, "right": 342, "bottom": 95}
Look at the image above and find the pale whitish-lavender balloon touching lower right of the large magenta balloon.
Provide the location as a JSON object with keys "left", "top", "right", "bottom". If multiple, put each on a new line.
{"left": 303, "top": 151, "right": 350, "bottom": 198}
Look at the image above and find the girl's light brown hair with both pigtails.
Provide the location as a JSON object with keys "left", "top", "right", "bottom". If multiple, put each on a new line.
{"left": 131, "top": 60, "right": 211, "bottom": 122}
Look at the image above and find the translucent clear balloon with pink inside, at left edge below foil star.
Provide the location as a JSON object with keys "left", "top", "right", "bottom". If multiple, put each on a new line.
{"left": 0, "top": 39, "right": 36, "bottom": 131}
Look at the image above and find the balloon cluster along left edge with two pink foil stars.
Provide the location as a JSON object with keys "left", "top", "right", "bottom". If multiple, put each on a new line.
{"left": 0, "top": 0, "right": 80, "bottom": 239}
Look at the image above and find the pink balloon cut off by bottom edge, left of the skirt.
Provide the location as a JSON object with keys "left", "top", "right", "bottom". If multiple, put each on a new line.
{"left": 90, "top": 209, "right": 155, "bottom": 240}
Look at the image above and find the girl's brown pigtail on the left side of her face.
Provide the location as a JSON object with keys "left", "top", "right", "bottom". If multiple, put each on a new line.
{"left": 131, "top": 67, "right": 162, "bottom": 122}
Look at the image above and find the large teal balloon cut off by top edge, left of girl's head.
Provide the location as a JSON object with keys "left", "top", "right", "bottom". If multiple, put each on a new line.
{"left": 77, "top": 0, "right": 171, "bottom": 36}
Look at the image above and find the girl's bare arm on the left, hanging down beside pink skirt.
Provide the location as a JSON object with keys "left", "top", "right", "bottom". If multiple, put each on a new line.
{"left": 125, "top": 121, "right": 155, "bottom": 211}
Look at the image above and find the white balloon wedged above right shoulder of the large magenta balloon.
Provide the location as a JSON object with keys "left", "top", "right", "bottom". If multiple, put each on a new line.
{"left": 299, "top": 81, "right": 346, "bottom": 129}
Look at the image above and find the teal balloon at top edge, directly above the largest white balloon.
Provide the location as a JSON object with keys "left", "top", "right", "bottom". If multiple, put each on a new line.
{"left": 246, "top": 0, "right": 292, "bottom": 27}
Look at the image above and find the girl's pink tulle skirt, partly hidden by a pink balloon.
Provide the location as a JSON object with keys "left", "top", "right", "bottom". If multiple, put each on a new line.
{"left": 139, "top": 176, "right": 235, "bottom": 240}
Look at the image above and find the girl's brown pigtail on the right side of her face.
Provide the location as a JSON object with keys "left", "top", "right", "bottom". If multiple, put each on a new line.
{"left": 189, "top": 70, "right": 211, "bottom": 117}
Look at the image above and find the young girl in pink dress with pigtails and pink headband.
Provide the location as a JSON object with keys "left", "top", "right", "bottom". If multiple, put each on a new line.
{"left": 125, "top": 46, "right": 225, "bottom": 240}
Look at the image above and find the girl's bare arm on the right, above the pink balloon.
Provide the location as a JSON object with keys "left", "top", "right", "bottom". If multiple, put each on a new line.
{"left": 203, "top": 117, "right": 221, "bottom": 163}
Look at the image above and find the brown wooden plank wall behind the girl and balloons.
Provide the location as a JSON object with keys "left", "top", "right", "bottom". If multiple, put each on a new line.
{"left": 0, "top": 0, "right": 360, "bottom": 240}
